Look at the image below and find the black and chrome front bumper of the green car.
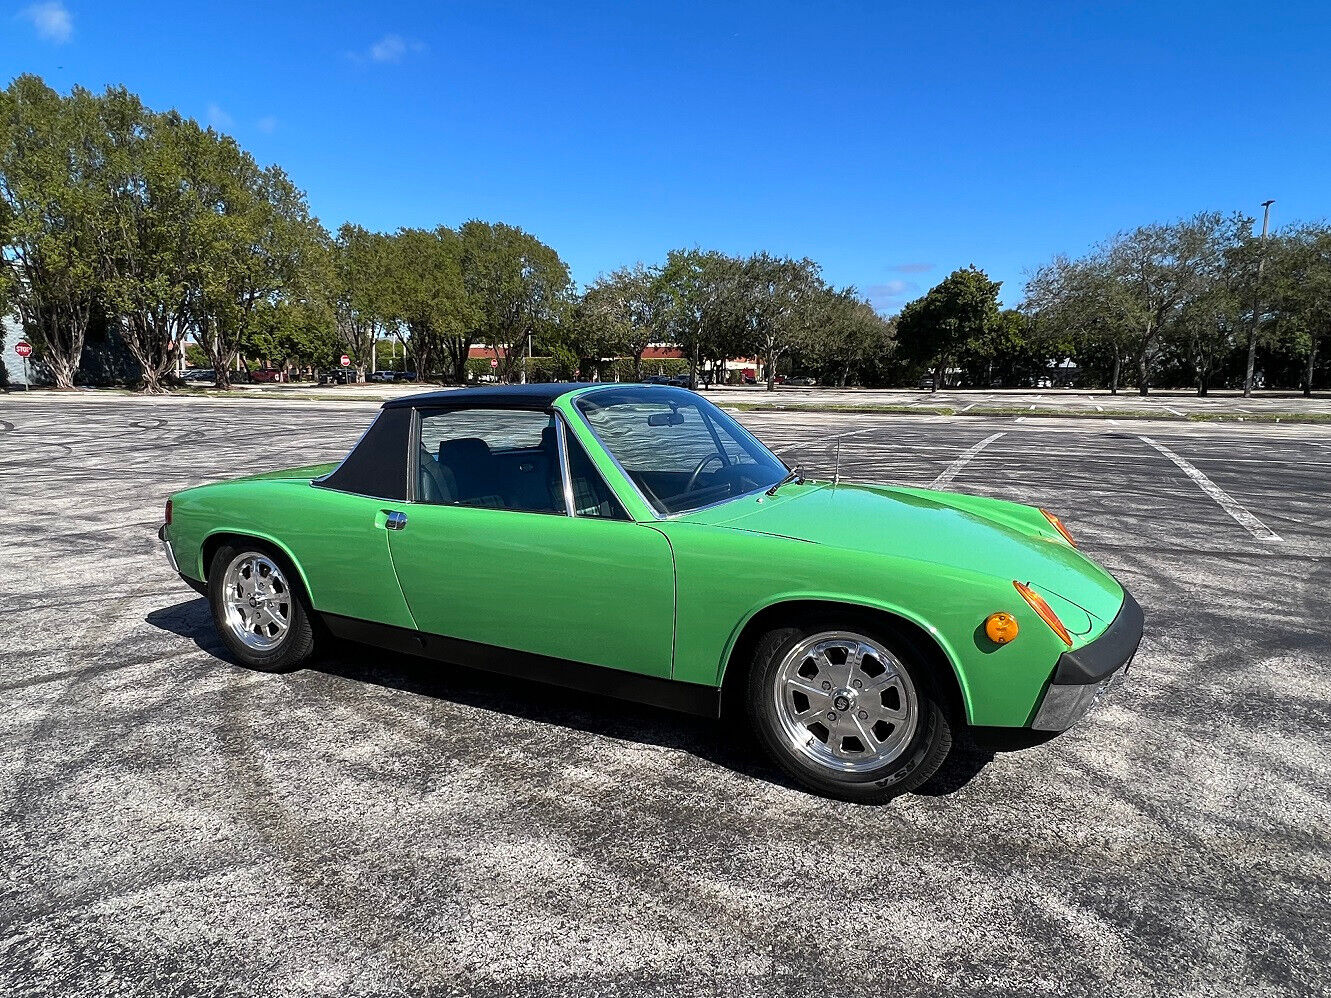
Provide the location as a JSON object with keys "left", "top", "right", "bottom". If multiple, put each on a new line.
{"left": 1030, "top": 589, "right": 1146, "bottom": 732}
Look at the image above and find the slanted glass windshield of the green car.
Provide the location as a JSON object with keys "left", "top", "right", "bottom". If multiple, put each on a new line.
{"left": 578, "top": 386, "right": 787, "bottom": 514}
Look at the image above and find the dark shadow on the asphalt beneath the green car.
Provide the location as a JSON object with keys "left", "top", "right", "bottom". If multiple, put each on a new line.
{"left": 145, "top": 597, "right": 994, "bottom": 797}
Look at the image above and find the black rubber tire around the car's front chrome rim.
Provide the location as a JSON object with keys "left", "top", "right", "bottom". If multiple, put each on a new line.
{"left": 745, "top": 619, "right": 952, "bottom": 804}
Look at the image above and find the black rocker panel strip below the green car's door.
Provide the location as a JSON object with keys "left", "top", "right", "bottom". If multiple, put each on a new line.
{"left": 322, "top": 613, "right": 721, "bottom": 717}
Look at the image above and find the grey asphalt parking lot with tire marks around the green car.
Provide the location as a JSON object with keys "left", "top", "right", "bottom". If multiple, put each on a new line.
{"left": 0, "top": 397, "right": 1331, "bottom": 995}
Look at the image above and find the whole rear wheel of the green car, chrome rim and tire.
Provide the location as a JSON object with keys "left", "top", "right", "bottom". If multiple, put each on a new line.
{"left": 208, "top": 542, "right": 314, "bottom": 672}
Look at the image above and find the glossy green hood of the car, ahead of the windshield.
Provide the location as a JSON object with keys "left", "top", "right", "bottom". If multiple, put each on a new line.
{"left": 681, "top": 482, "right": 1123, "bottom": 633}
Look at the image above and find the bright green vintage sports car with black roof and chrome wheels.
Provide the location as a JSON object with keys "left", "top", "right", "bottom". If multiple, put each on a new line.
{"left": 160, "top": 385, "right": 1142, "bottom": 802}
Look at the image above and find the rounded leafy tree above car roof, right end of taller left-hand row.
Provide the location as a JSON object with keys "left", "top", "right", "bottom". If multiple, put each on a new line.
{"left": 460, "top": 220, "right": 571, "bottom": 381}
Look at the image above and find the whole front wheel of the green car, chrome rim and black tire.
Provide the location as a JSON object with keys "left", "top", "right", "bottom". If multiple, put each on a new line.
{"left": 748, "top": 624, "right": 952, "bottom": 804}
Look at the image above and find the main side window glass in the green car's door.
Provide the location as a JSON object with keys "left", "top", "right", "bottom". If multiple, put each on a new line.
{"left": 417, "top": 409, "right": 564, "bottom": 514}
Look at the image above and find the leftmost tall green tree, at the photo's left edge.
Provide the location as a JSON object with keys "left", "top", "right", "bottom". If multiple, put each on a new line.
{"left": 0, "top": 75, "right": 105, "bottom": 389}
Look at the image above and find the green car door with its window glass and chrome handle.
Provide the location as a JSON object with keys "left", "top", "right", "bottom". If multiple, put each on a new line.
{"left": 389, "top": 409, "right": 675, "bottom": 679}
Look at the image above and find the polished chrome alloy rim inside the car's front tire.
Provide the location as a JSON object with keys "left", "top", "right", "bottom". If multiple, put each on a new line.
{"left": 772, "top": 631, "right": 920, "bottom": 773}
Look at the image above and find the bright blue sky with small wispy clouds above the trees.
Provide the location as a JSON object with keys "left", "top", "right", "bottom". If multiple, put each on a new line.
{"left": 0, "top": 0, "right": 1331, "bottom": 313}
